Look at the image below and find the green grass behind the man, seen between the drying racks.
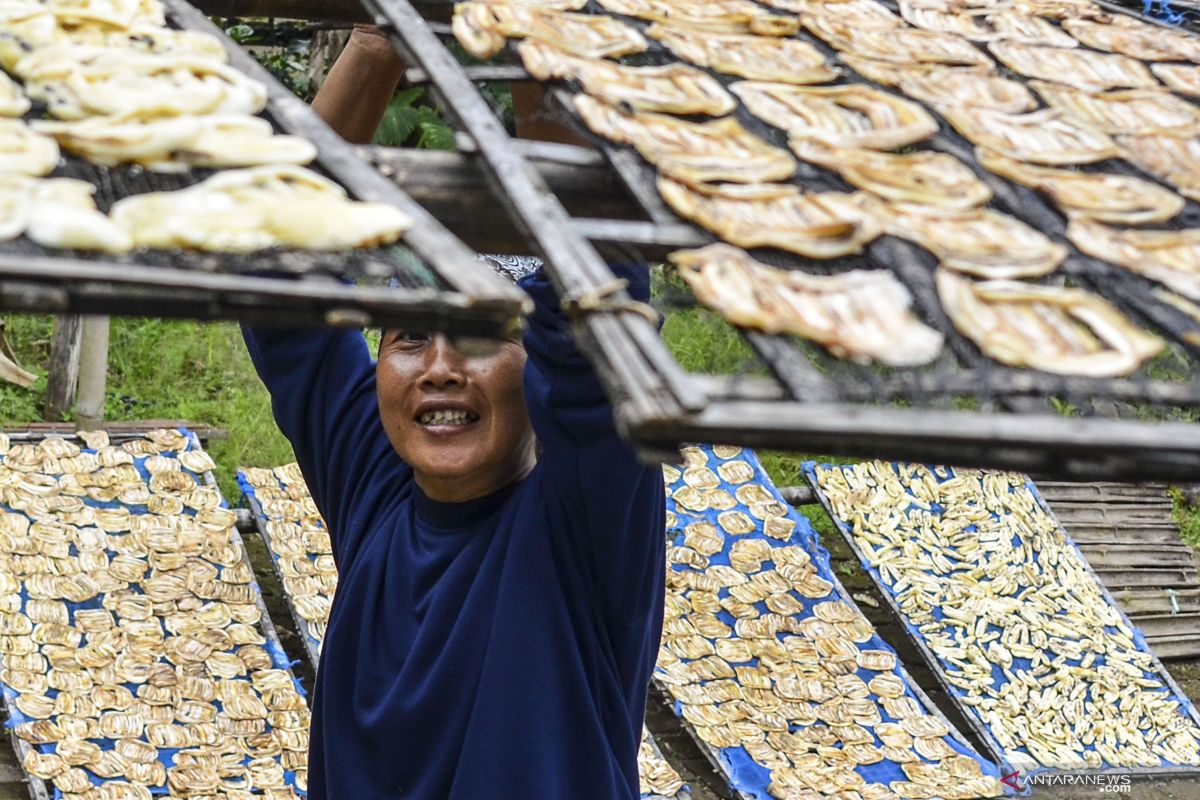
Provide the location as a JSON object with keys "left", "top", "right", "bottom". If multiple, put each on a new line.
{"left": 7, "top": 308, "right": 1200, "bottom": 547}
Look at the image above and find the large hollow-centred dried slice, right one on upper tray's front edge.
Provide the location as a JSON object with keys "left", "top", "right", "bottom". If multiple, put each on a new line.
{"left": 937, "top": 270, "right": 1165, "bottom": 378}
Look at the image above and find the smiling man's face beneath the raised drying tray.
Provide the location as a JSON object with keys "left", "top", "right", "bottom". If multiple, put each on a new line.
{"left": 376, "top": 331, "right": 536, "bottom": 503}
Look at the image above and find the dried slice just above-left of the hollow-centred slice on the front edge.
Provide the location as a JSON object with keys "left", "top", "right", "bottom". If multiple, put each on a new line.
{"left": 874, "top": 203, "right": 1067, "bottom": 278}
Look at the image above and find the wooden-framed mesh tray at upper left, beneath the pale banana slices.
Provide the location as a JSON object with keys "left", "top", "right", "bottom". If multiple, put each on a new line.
{"left": 0, "top": 0, "right": 524, "bottom": 336}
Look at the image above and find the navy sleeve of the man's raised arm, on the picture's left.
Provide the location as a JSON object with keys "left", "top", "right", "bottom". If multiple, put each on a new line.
{"left": 242, "top": 326, "right": 410, "bottom": 569}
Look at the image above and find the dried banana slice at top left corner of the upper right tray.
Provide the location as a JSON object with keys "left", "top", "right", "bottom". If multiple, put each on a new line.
{"left": 451, "top": 2, "right": 647, "bottom": 59}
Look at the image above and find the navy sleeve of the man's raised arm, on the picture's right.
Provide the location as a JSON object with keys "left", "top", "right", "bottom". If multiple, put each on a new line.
{"left": 521, "top": 265, "right": 665, "bottom": 625}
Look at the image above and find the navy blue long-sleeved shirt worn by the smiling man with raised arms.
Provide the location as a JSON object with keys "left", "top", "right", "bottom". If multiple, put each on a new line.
{"left": 246, "top": 267, "right": 665, "bottom": 800}
